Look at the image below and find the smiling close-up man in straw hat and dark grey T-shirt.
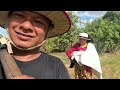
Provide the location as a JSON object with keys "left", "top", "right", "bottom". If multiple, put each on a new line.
{"left": 0, "top": 11, "right": 71, "bottom": 79}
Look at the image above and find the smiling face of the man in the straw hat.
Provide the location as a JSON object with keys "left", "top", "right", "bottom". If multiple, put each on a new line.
{"left": 8, "top": 11, "right": 49, "bottom": 48}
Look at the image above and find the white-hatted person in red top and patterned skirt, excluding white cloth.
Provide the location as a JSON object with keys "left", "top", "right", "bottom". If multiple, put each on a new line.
{"left": 66, "top": 33, "right": 92, "bottom": 79}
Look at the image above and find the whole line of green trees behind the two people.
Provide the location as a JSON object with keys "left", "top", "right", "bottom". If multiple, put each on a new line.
{"left": 42, "top": 11, "right": 120, "bottom": 53}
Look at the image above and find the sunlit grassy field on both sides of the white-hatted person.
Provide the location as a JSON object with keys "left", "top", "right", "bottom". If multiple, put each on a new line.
{"left": 51, "top": 50, "right": 120, "bottom": 79}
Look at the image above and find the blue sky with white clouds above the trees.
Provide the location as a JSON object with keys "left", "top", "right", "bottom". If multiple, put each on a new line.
{"left": 0, "top": 11, "right": 106, "bottom": 36}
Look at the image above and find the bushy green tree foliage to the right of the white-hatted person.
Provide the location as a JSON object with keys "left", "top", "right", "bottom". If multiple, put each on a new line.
{"left": 84, "top": 18, "right": 120, "bottom": 53}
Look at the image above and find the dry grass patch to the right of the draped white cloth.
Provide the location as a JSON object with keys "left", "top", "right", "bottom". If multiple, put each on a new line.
{"left": 100, "top": 50, "right": 120, "bottom": 79}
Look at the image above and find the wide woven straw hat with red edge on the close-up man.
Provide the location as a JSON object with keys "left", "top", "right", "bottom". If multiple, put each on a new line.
{"left": 0, "top": 11, "right": 71, "bottom": 38}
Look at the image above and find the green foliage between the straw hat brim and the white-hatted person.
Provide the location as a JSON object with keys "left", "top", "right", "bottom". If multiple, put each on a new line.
{"left": 43, "top": 11, "right": 82, "bottom": 52}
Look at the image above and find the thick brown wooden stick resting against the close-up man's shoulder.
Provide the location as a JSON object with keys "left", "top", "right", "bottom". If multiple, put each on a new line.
{"left": 0, "top": 49, "right": 22, "bottom": 79}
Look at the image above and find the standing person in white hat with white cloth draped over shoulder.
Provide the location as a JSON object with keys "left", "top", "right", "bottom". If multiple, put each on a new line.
{"left": 66, "top": 33, "right": 102, "bottom": 79}
